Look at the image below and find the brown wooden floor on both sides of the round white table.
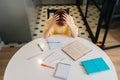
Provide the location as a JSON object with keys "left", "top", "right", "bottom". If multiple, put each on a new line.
{"left": 0, "top": 48, "right": 120, "bottom": 80}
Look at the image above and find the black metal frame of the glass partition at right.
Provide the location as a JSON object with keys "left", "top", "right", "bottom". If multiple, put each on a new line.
{"left": 76, "top": 0, "right": 120, "bottom": 49}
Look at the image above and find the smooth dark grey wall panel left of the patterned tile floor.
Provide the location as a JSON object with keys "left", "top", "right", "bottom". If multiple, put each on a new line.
{"left": 0, "top": 0, "right": 31, "bottom": 43}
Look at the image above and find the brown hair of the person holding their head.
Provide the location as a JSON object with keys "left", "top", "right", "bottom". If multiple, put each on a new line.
{"left": 55, "top": 9, "right": 68, "bottom": 26}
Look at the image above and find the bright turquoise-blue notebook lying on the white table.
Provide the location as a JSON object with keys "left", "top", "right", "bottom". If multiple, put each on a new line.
{"left": 82, "top": 58, "right": 110, "bottom": 74}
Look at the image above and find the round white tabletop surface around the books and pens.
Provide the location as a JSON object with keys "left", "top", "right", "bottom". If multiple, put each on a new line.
{"left": 4, "top": 35, "right": 118, "bottom": 80}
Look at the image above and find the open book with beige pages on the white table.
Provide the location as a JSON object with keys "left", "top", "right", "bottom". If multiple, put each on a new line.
{"left": 62, "top": 41, "right": 92, "bottom": 60}
